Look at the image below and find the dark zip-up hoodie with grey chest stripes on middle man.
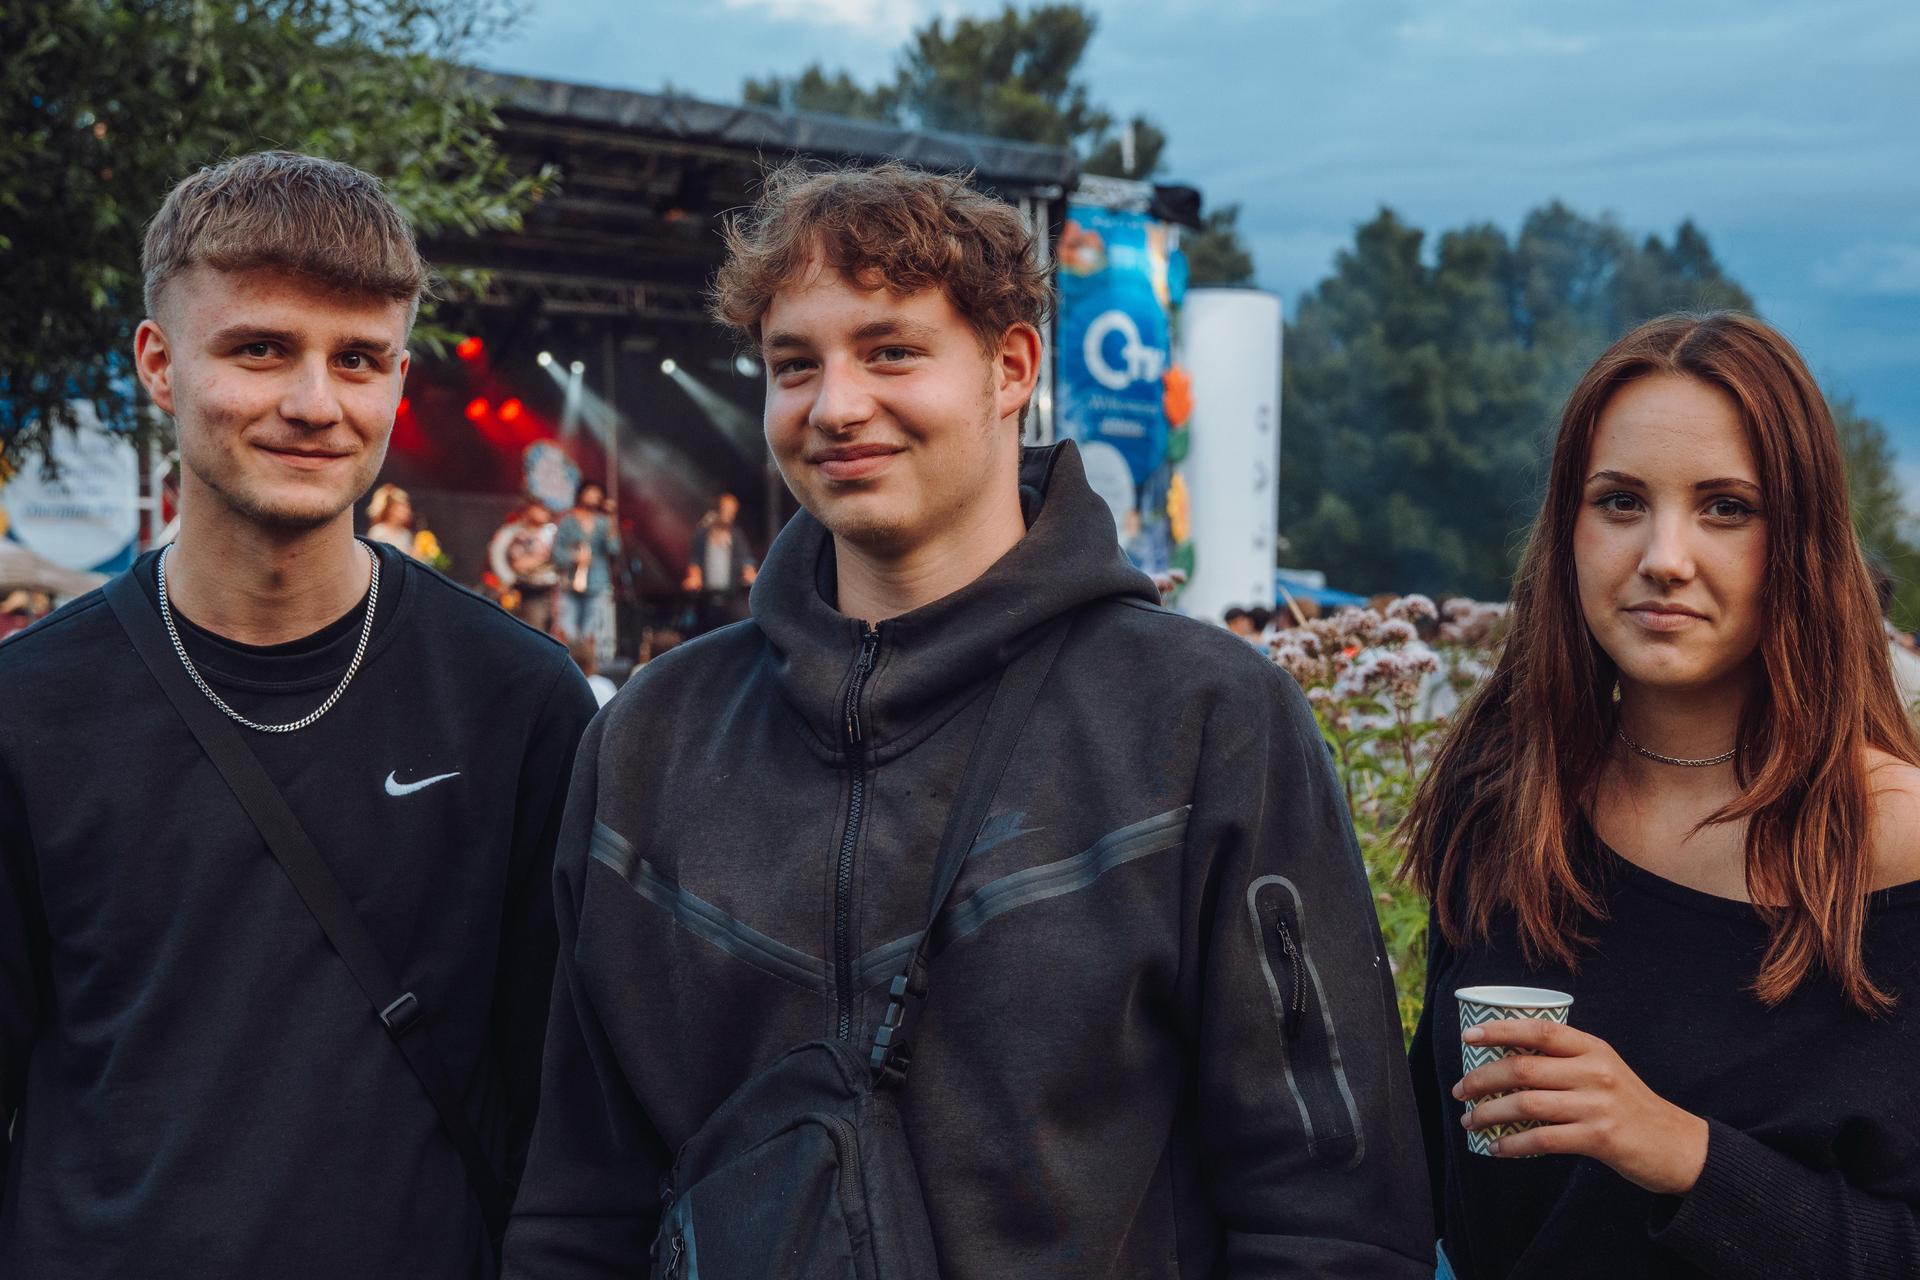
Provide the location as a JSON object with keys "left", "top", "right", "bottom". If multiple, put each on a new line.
{"left": 507, "top": 445, "right": 1432, "bottom": 1280}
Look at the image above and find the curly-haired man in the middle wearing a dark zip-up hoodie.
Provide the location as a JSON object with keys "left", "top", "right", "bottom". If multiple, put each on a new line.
{"left": 507, "top": 165, "right": 1432, "bottom": 1280}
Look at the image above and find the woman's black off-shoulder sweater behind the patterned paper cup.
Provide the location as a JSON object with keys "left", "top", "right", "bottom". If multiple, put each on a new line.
{"left": 1411, "top": 835, "right": 1920, "bottom": 1280}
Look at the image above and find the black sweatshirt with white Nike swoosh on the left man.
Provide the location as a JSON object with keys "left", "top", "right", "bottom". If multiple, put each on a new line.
{"left": 0, "top": 547, "right": 593, "bottom": 1280}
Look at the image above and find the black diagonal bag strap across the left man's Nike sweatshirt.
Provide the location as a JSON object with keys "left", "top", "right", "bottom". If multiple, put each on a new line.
{"left": 106, "top": 570, "right": 509, "bottom": 1253}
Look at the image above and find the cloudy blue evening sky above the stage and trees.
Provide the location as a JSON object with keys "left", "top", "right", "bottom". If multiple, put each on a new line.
{"left": 486, "top": 0, "right": 1920, "bottom": 495}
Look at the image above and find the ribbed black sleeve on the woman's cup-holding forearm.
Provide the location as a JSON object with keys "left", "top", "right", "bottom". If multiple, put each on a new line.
{"left": 1653, "top": 1121, "right": 1920, "bottom": 1280}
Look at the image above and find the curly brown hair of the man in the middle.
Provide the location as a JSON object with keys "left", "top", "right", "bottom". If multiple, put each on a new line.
{"left": 710, "top": 161, "right": 1052, "bottom": 351}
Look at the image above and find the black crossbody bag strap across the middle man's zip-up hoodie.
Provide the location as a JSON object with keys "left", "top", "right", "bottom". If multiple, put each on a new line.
{"left": 870, "top": 614, "right": 1073, "bottom": 1086}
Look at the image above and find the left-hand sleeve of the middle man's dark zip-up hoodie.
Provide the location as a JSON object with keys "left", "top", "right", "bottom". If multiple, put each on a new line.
{"left": 505, "top": 704, "right": 668, "bottom": 1280}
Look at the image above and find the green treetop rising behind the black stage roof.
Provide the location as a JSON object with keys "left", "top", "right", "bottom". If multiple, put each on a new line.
{"left": 741, "top": 4, "right": 1254, "bottom": 284}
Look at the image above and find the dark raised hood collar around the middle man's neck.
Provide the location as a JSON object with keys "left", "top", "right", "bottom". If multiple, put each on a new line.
{"left": 749, "top": 441, "right": 1160, "bottom": 762}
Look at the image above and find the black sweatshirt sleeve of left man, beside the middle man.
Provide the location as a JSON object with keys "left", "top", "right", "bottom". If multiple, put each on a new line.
{"left": 492, "top": 656, "right": 597, "bottom": 1186}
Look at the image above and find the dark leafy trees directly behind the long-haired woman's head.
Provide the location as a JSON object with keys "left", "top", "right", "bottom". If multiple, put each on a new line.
{"left": 1281, "top": 201, "right": 1753, "bottom": 599}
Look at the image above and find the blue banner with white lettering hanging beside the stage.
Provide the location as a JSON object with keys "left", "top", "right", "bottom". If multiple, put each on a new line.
{"left": 1054, "top": 203, "right": 1185, "bottom": 570}
